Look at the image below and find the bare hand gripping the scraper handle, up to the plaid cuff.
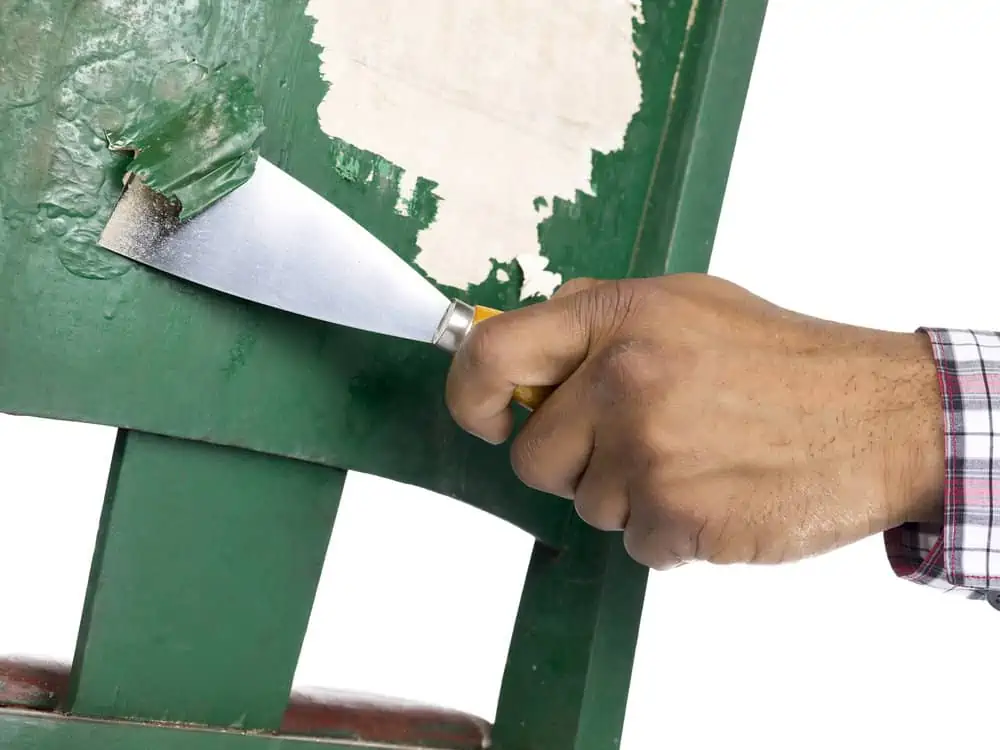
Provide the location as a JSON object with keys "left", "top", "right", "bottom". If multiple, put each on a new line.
{"left": 447, "top": 274, "right": 944, "bottom": 569}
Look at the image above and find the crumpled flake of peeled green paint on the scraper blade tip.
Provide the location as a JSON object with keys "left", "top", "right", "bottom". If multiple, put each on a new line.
{"left": 108, "top": 62, "right": 264, "bottom": 219}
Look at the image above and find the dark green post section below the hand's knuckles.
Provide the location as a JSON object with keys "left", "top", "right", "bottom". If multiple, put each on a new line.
{"left": 493, "top": 517, "right": 648, "bottom": 750}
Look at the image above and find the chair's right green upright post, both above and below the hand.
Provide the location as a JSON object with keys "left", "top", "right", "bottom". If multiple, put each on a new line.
{"left": 493, "top": 0, "right": 767, "bottom": 750}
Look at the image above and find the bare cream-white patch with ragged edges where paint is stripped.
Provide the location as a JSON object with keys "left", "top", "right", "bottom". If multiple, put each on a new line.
{"left": 307, "top": 0, "right": 642, "bottom": 298}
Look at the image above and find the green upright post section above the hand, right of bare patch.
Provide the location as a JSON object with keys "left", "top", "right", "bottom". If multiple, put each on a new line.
{"left": 629, "top": 0, "right": 767, "bottom": 276}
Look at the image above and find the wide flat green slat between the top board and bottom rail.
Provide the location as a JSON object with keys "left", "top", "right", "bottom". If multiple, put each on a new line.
{"left": 64, "top": 430, "right": 346, "bottom": 730}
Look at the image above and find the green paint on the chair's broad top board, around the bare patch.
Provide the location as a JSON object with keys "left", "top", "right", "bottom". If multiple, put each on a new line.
{"left": 0, "top": 0, "right": 716, "bottom": 541}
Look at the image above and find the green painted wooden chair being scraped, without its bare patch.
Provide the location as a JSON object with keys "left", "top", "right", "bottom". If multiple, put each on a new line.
{"left": 0, "top": 0, "right": 765, "bottom": 750}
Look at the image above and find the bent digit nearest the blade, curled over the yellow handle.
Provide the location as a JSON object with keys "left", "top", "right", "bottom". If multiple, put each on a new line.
{"left": 445, "top": 279, "right": 616, "bottom": 443}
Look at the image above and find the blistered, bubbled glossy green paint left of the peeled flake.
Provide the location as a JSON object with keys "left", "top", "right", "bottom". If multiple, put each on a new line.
{"left": 0, "top": 0, "right": 268, "bottom": 279}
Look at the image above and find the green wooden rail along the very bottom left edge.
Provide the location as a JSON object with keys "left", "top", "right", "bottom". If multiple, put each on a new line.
{"left": 0, "top": 709, "right": 400, "bottom": 750}
